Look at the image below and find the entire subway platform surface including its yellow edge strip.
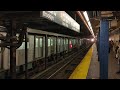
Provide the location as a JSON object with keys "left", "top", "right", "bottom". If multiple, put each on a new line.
{"left": 69, "top": 44, "right": 120, "bottom": 79}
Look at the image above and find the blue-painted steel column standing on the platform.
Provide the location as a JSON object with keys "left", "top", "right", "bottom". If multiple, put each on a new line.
{"left": 99, "top": 19, "right": 109, "bottom": 79}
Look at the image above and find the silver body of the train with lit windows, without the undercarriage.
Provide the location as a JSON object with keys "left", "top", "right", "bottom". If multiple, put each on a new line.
{"left": 0, "top": 28, "right": 83, "bottom": 72}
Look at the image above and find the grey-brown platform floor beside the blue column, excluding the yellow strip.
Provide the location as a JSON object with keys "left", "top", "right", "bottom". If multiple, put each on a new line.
{"left": 87, "top": 44, "right": 120, "bottom": 79}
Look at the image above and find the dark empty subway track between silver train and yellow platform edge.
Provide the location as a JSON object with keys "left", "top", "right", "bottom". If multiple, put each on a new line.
{"left": 30, "top": 45, "right": 91, "bottom": 79}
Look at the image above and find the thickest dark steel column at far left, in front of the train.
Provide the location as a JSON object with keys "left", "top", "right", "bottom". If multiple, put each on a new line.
{"left": 4, "top": 19, "right": 16, "bottom": 79}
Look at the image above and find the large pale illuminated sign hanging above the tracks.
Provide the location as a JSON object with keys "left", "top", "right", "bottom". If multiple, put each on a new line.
{"left": 41, "top": 11, "right": 80, "bottom": 32}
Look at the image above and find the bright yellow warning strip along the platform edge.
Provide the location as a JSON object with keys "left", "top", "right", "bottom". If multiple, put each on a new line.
{"left": 69, "top": 46, "right": 93, "bottom": 79}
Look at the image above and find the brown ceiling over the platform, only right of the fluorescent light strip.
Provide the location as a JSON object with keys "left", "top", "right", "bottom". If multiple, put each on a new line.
{"left": 88, "top": 11, "right": 120, "bottom": 33}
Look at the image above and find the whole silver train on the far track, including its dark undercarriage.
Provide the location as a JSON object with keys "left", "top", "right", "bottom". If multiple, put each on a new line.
{"left": 0, "top": 28, "right": 90, "bottom": 73}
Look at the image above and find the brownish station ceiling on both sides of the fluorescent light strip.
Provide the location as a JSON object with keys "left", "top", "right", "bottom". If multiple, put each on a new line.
{"left": 66, "top": 11, "right": 120, "bottom": 36}
